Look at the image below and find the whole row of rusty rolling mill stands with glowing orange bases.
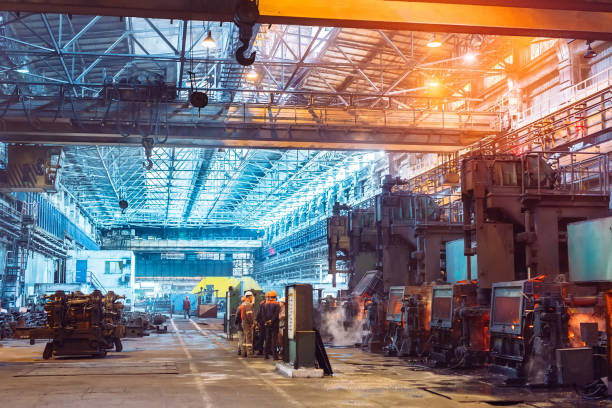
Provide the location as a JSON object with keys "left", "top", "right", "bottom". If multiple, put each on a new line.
{"left": 328, "top": 152, "right": 612, "bottom": 385}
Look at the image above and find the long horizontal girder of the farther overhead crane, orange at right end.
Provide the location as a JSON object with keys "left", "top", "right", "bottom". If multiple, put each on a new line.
{"left": 0, "top": 120, "right": 495, "bottom": 152}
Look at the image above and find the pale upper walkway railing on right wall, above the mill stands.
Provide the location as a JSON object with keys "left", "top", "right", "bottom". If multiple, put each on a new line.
{"left": 512, "top": 67, "right": 612, "bottom": 129}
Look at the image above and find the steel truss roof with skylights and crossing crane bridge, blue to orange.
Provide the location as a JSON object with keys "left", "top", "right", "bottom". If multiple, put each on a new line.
{"left": 0, "top": 12, "right": 512, "bottom": 230}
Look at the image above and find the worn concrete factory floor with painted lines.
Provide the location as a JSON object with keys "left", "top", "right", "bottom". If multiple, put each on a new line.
{"left": 0, "top": 318, "right": 612, "bottom": 408}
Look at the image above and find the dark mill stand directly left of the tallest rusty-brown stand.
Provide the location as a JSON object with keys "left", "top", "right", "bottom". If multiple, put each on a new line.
{"left": 376, "top": 176, "right": 463, "bottom": 356}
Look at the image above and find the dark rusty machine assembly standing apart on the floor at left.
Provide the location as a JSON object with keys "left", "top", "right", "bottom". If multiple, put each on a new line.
{"left": 15, "top": 290, "right": 125, "bottom": 360}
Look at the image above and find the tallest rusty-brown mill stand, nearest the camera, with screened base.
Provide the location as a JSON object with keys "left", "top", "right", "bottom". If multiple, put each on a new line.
{"left": 459, "top": 153, "right": 609, "bottom": 384}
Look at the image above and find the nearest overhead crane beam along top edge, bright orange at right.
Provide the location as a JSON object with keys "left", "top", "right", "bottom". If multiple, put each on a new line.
{"left": 0, "top": 0, "right": 612, "bottom": 40}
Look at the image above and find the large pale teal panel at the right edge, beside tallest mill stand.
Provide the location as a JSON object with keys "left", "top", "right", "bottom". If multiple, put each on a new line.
{"left": 567, "top": 217, "right": 612, "bottom": 282}
